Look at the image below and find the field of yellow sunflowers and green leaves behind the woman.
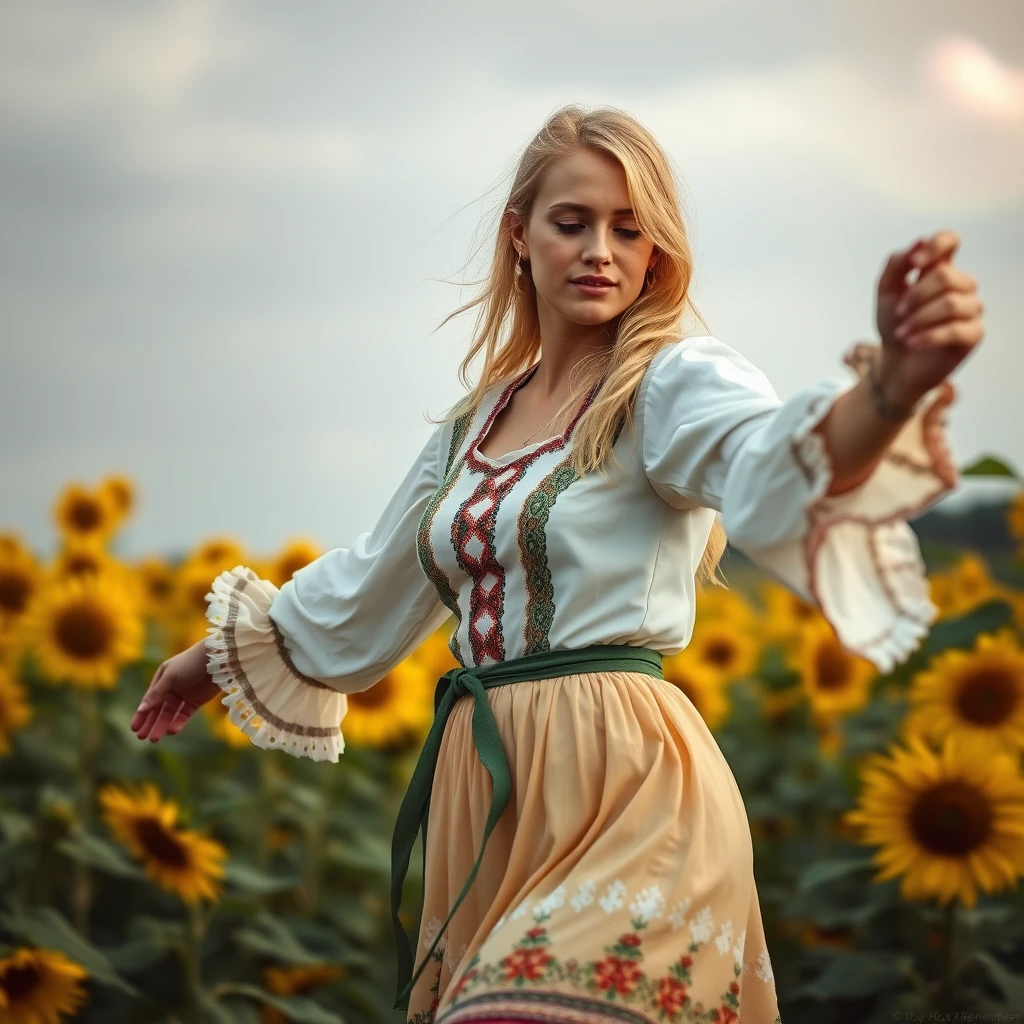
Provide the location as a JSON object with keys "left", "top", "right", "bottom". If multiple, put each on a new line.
{"left": 0, "top": 475, "right": 1024, "bottom": 1024}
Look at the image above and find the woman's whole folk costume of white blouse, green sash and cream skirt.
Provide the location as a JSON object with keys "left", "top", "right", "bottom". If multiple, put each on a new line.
{"left": 207, "top": 337, "right": 956, "bottom": 1024}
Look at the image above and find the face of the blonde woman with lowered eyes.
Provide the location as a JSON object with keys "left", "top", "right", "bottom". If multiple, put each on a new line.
{"left": 512, "top": 150, "right": 657, "bottom": 325}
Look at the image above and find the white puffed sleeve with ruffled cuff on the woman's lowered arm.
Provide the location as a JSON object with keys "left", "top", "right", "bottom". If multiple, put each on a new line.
{"left": 206, "top": 422, "right": 452, "bottom": 761}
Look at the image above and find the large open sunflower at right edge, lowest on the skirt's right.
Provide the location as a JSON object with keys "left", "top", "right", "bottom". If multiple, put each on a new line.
{"left": 844, "top": 735, "right": 1024, "bottom": 907}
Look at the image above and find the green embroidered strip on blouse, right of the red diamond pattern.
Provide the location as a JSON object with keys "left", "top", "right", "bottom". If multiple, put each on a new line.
{"left": 518, "top": 456, "right": 579, "bottom": 654}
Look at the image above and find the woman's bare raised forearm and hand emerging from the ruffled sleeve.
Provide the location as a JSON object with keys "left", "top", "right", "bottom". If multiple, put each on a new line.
{"left": 814, "top": 230, "right": 984, "bottom": 496}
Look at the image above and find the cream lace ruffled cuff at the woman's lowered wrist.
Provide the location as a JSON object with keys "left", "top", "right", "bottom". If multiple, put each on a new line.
{"left": 206, "top": 565, "right": 348, "bottom": 761}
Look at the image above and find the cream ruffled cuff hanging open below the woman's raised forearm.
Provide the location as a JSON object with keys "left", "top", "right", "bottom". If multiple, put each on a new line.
{"left": 757, "top": 343, "right": 957, "bottom": 672}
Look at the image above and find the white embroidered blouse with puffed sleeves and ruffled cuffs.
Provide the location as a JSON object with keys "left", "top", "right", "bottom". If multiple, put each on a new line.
{"left": 206, "top": 337, "right": 956, "bottom": 761}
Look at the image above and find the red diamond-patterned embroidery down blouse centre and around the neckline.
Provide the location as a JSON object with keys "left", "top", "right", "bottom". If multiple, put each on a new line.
{"left": 452, "top": 366, "right": 599, "bottom": 666}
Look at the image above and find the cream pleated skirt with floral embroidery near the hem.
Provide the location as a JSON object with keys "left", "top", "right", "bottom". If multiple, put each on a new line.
{"left": 409, "top": 672, "right": 779, "bottom": 1024}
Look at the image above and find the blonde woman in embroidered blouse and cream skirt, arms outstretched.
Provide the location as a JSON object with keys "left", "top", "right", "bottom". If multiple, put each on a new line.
{"left": 132, "top": 106, "right": 983, "bottom": 1024}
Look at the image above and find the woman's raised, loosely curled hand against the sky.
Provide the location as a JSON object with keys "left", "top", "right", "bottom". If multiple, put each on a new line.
{"left": 876, "top": 231, "right": 985, "bottom": 407}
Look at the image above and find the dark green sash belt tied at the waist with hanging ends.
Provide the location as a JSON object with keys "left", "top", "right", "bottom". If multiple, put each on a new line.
{"left": 391, "top": 644, "right": 665, "bottom": 1010}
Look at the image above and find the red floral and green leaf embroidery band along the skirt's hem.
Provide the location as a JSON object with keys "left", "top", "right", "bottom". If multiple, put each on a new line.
{"left": 442, "top": 914, "right": 757, "bottom": 1024}
